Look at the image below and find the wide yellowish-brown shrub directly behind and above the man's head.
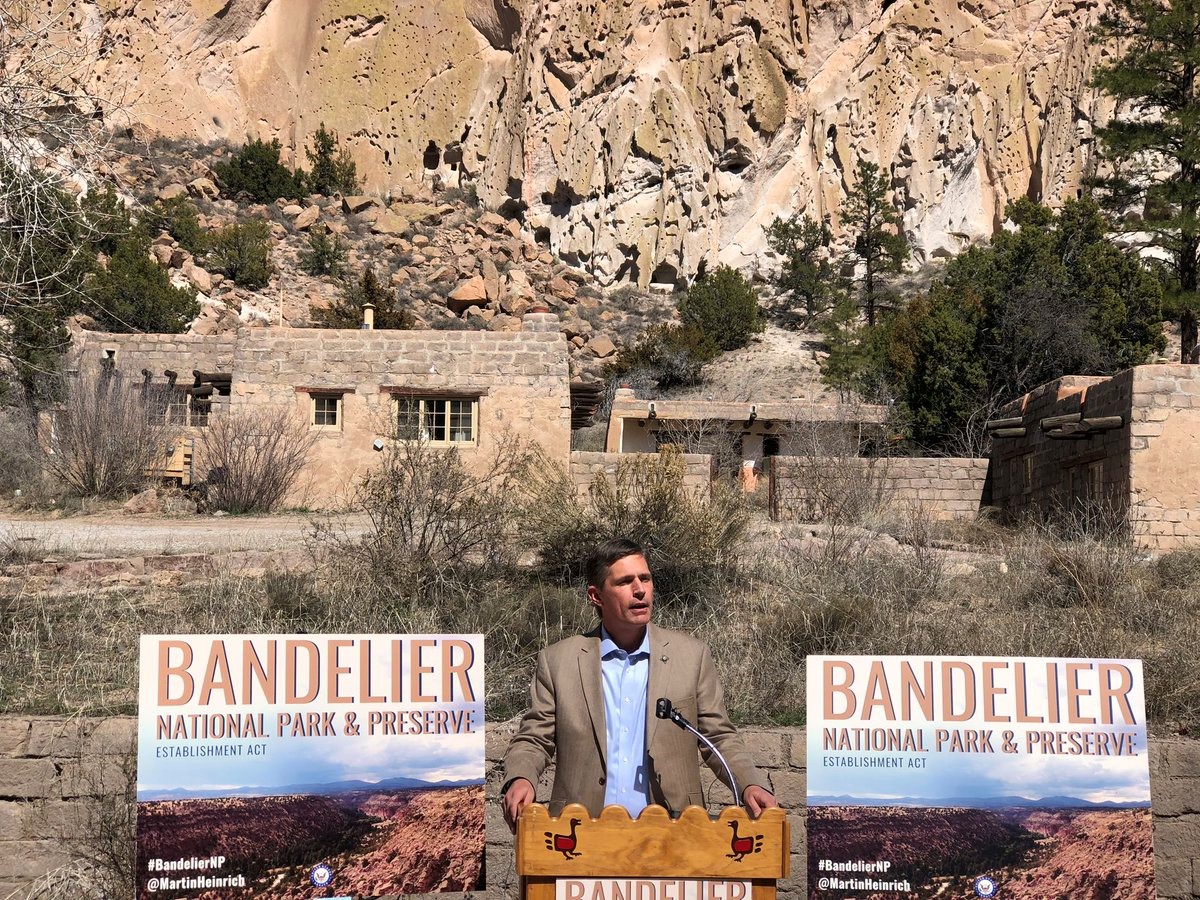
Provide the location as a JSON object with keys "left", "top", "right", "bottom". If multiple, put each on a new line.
{"left": 523, "top": 446, "right": 750, "bottom": 601}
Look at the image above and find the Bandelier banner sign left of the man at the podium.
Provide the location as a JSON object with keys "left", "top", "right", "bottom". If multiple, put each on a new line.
{"left": 137, "top": 635, "right": 484, "bottom": 899}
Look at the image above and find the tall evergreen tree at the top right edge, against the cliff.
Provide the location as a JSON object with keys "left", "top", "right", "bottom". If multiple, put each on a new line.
{"left": 1094, "top": 0, "right": 1200, "bottom": 362}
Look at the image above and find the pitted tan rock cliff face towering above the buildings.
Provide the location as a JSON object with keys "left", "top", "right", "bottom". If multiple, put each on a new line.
{"left": 86, "top": 0, "right": 1110, "bottom": 284}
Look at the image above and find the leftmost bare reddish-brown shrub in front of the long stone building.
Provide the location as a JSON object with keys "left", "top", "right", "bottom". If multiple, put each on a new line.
{"left": 44, "top": 368, "right": 175, "bottom": 497}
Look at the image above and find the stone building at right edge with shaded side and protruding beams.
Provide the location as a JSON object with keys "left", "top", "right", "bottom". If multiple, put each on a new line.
{"left": 988, "top": 365, "right": 1200, "bottom": 550}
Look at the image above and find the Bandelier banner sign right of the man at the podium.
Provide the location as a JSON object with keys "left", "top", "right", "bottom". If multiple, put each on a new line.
{"left": 806, "top": 656, "right": 1154, "bottom": 900}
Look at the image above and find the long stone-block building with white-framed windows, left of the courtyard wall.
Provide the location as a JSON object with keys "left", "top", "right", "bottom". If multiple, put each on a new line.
{"left": 72, "top": 313, "right": 571, "bottom": 508}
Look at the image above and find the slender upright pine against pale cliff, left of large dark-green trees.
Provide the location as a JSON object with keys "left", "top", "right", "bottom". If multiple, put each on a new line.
{"left": 841, "top": 160, "right": 908, "bottom": 325}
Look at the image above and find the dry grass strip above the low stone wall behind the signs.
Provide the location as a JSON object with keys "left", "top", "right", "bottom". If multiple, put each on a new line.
{"left": 0, "top": 520, "right": 1200, "bottom": 733}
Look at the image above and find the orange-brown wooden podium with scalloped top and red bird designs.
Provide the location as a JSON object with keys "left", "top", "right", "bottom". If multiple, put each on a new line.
{"left": 516, "top": 803, "right": 791, "bottom": 900}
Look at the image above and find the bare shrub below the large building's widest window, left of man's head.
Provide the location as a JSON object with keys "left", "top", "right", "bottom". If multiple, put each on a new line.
{"left": 316, "top": 437, "right": 532, "bottom": 602}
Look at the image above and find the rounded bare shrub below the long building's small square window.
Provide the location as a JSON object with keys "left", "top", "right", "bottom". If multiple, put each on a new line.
{"left": 199, "top": 408, "right": 317, "bottom": 512}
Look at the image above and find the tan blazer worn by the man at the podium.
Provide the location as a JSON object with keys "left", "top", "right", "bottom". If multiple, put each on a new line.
{"left": 504, "top": 625, "right": 767, "bottom": 816}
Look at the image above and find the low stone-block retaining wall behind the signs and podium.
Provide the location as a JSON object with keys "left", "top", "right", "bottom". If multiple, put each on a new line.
{"left": 0, "top": 716, "right": 1200, "bottom": 900}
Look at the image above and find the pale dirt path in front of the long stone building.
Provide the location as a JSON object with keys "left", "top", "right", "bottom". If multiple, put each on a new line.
{"left": 0, "top": 515, "right": 361, "bottom": 558}
